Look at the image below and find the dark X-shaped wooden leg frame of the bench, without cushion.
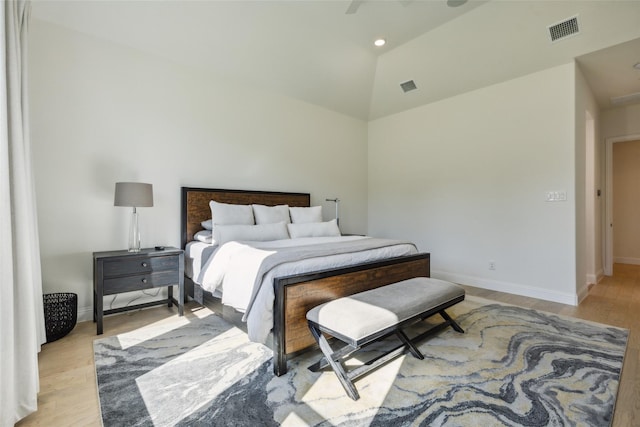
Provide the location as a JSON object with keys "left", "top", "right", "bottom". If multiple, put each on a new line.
{"left": 308, "top": 295, "right": 464, "bottom": 400}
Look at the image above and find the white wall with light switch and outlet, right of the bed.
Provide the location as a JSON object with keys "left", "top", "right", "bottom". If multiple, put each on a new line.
{"left": 369, "top": 63, "right": 576, "bottom": 304}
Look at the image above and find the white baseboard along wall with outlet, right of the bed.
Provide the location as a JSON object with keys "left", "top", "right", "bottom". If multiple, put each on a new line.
{"left": 431, "top": 270, "right": 579, "bottom": 305}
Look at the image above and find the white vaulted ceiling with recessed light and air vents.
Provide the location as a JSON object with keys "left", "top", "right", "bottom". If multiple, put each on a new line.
{"left": 32, "top": 0, "right": 640, "bottom": 120}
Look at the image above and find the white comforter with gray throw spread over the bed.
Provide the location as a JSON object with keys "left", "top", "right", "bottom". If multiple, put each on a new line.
{"left": 197, "top": 236, "right": 417, "bottom": 343}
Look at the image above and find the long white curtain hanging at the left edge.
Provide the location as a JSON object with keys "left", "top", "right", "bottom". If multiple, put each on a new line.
{"left": 0, "top": 0, "right": 46, "bottom": 427}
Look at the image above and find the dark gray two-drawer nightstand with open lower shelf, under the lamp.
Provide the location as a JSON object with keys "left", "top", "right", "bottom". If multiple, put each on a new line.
{"left": 93, "top": 248, "right": 184, "bottom": 335}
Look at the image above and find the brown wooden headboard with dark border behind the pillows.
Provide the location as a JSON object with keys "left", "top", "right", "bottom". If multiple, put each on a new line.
{"left": 180, "top": 187, "right": 311, "bottom": 249}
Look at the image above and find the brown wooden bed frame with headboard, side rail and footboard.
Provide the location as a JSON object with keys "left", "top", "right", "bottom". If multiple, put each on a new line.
{"left": 181, "top": 187, "right": 430, "bottom": 376}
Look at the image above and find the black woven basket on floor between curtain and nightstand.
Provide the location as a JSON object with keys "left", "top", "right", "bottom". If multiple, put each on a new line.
{"left": 42, "top": 293, "right": 78, "bottom": 343}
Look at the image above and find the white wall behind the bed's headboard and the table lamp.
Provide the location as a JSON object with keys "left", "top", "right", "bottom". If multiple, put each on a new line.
{"left": 29, "top": 20, "right": 367, "bottom": 319}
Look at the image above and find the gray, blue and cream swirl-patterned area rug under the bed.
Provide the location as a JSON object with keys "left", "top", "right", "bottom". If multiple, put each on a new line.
{"left": 94, "top": 297, "right": 628, "bottom": 427}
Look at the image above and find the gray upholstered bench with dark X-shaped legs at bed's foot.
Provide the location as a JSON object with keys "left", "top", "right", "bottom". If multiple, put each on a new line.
{"left": 307, "top": 277, "right": 465, "bottom": 400}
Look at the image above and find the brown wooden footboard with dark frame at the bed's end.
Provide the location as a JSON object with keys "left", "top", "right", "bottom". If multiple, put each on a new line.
{"left": 273, "top": 253, "right": 430, "bottom": 376}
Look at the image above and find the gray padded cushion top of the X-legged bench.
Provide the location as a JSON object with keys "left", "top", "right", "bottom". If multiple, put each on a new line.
{"left": 307, "top": 277, "right": 465, "bottom": 341}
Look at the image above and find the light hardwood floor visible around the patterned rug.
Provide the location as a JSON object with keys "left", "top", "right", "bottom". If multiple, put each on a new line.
{"left": 17, "top": 264, "right": 640, "bottom": 427}
